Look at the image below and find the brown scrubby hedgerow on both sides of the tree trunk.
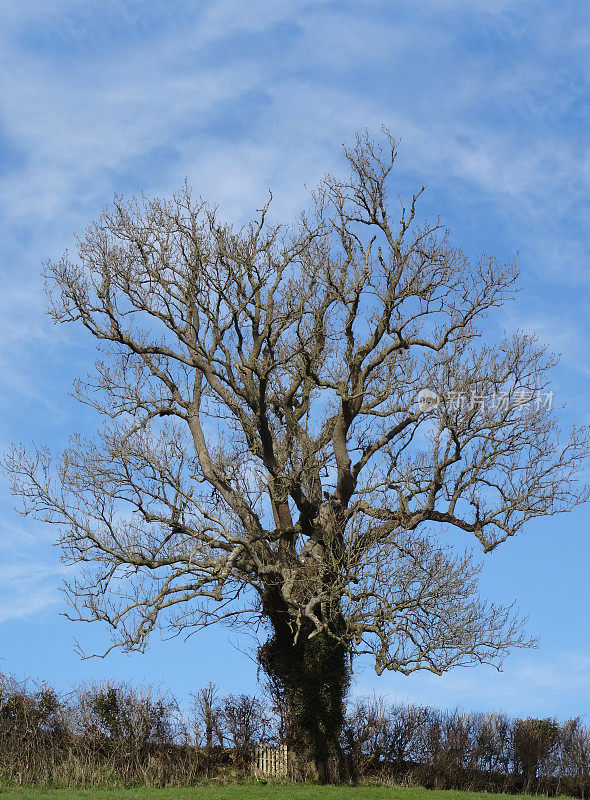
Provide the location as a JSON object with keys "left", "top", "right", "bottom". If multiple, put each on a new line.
{"left": 0, "top": 674, "right": 590, "bottom": 797}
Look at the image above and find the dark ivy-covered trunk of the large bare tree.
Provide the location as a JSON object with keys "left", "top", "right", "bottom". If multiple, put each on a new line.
{"left": 258, "top": 590, "right": 350, "bottom": 783}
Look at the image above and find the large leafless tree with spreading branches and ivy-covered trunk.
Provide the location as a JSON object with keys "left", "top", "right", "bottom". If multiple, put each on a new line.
{"left": 7, "top": 135, "right": 587, "bottom": 780}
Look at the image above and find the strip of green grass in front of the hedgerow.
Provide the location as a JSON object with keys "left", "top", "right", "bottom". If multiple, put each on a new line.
{"left": 0, "top": 783, "right": 580, "bottom": 800}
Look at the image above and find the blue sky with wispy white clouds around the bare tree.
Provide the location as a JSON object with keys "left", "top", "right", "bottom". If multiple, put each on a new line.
{"left": 0, "top": 0, "right": 590, "bottom": 724}
